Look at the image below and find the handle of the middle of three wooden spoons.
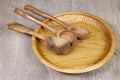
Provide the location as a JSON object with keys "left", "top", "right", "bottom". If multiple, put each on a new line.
{"left": 14, "top": 8, "right": 57, "bottom": 34}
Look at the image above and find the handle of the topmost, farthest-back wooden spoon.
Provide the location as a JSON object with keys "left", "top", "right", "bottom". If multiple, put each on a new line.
{"left": 24, "top": 5, "right": 67, "bottom": 28}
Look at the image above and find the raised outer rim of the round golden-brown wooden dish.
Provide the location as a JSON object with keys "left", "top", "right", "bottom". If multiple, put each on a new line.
{"left": 32, "top": 12, "right": 116, "bottom": 74}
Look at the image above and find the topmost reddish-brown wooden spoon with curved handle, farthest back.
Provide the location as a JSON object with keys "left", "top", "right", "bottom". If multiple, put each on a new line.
{"left": 24, "top": 5, "right": 89, "bottom": 39}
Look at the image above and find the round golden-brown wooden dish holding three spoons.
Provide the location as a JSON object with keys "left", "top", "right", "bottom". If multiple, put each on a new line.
{"left": 32, "top": 12, "right": 116, "bottom": 73}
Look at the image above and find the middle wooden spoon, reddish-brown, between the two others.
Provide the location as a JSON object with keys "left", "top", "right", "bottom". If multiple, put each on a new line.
{"left": 14, "top": 8, "right": 77, "bottom": 45}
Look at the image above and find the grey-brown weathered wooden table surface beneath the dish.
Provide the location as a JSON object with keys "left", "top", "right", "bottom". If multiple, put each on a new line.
{"left": 0, "top": 0, "right": 120, "bottom": 80}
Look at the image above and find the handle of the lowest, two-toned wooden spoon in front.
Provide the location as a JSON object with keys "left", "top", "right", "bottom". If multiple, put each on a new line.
{"left": 8, "top": 22, "right": 46, "bottom": 41}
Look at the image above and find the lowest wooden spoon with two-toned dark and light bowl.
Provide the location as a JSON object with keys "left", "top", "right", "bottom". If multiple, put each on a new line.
{"left": 8, "top": 22, "right": 71, "bottom": 55}
